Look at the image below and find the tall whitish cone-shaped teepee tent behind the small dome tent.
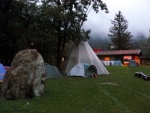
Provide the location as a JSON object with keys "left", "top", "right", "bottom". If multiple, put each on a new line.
{"left": 61, "top": 42, "right": 109, "bottom": 75}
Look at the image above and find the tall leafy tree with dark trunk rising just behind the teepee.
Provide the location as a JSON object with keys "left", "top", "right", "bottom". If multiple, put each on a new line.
{"left": 37, "top": 0, "right": 108, "bottom": 68}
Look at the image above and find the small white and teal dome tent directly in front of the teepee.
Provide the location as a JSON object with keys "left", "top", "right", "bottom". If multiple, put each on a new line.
{"left": 67, "top": 63, "right": 97, "bottom": 77}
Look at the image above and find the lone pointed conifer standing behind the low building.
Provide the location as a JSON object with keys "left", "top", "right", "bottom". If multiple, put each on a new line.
{"left": 108, "top": 11, "right": 132, "bottom": 50}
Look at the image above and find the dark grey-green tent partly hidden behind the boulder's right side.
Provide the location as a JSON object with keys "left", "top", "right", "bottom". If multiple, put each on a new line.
{"left": 44, "top": 63, "right": 62, "bottom": 79}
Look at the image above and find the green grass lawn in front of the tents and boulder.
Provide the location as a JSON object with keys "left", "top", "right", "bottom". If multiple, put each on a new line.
{"left": 0, "top": 66, "right": 150, "bottom": 113}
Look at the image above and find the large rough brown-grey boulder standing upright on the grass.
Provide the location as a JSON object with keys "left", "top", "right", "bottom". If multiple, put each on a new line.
{"left": 2, "top": 49, "right": 46, "bottom": 99}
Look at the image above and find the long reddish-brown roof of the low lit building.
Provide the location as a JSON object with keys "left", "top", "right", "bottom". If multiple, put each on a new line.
{"left": 95, "top": 50, "right": 141, "bottom": 55}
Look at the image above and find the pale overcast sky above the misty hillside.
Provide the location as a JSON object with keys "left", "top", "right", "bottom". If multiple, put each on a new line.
{"left": 84, "top": 0, "right": 150, "bottom": 37}
